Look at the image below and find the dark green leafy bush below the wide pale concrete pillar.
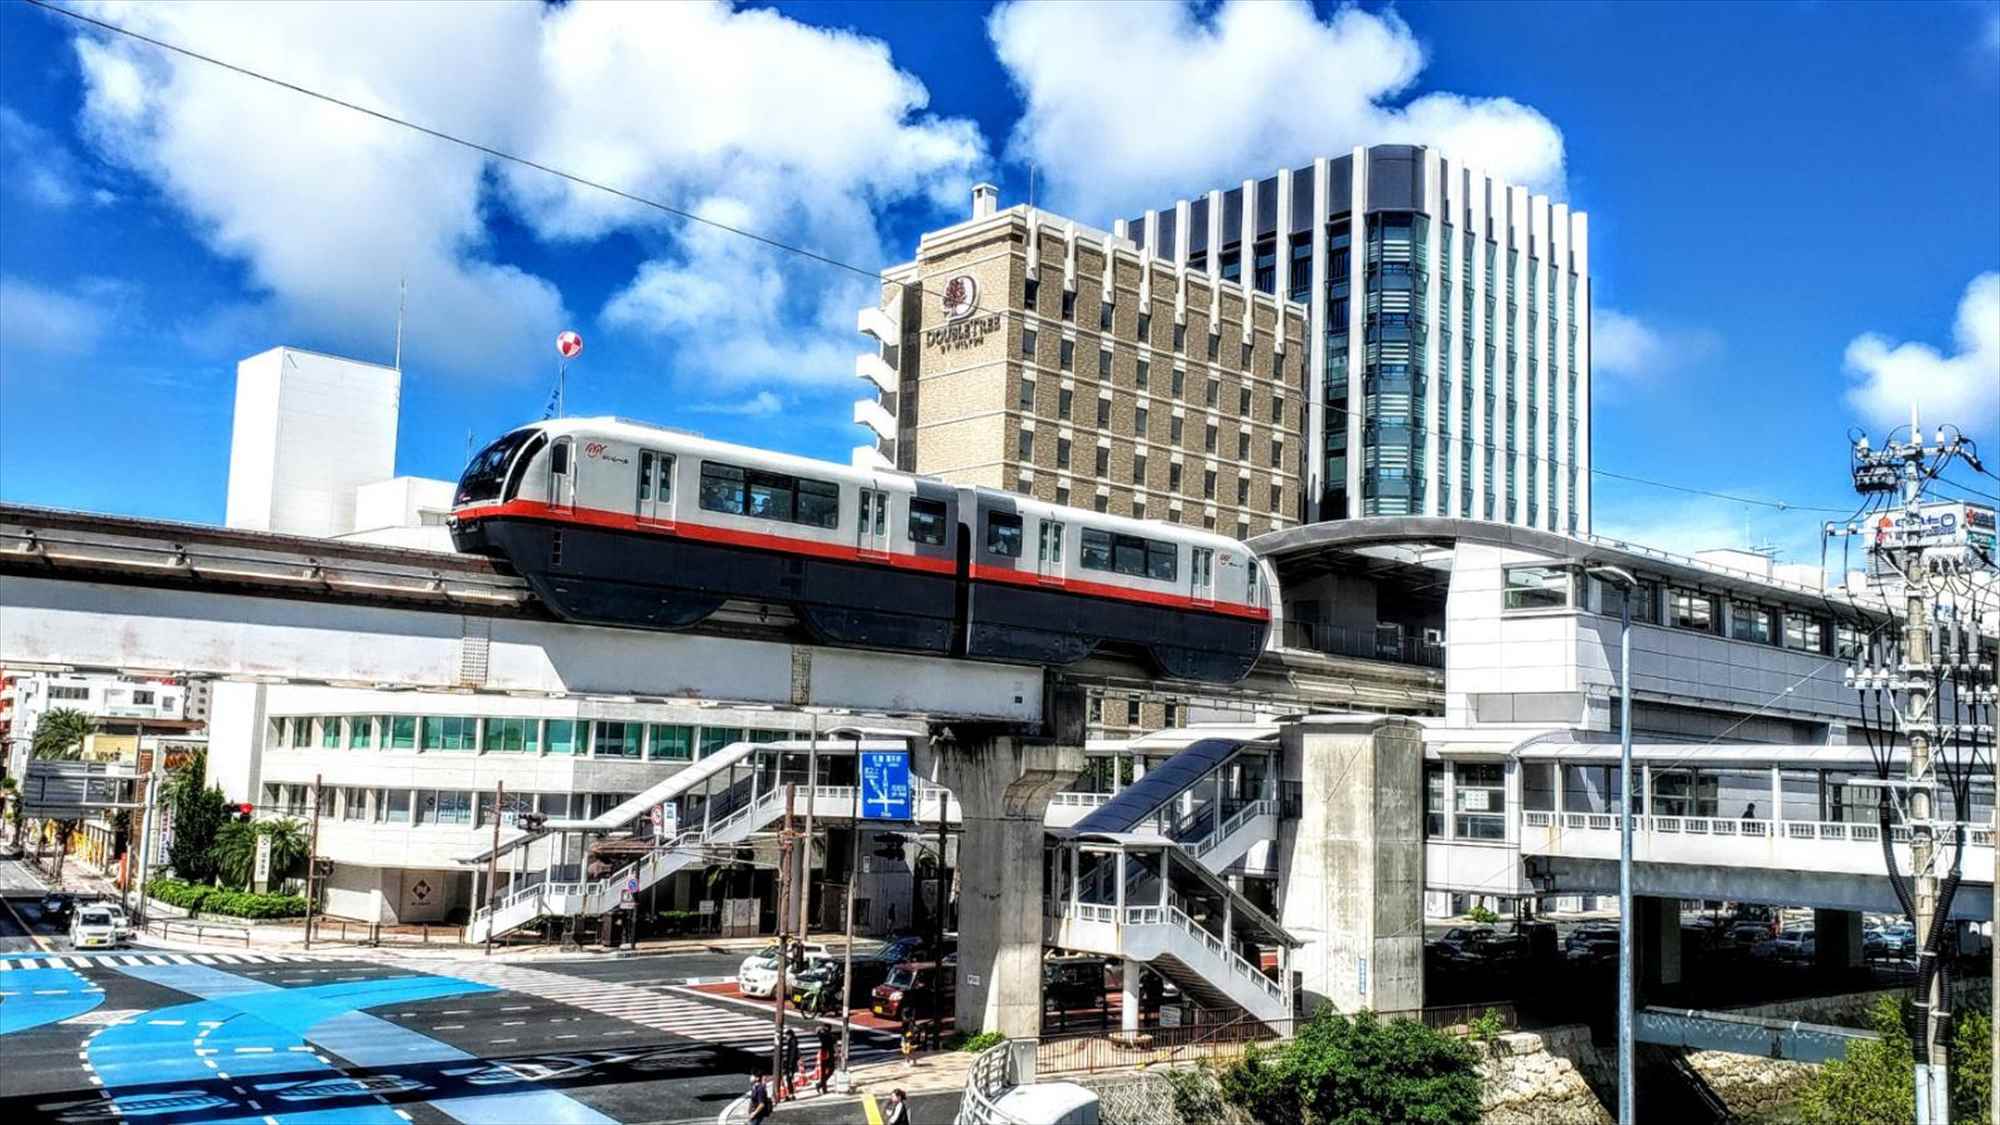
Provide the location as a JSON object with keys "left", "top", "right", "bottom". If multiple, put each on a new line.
{"left": 1220, "top": 1009, "right": 1480, "bottom": 1125}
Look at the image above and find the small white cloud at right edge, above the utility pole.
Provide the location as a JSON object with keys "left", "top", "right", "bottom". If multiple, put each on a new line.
{"left": 1846, "top": 272, "right": 2000, "bottom": 440}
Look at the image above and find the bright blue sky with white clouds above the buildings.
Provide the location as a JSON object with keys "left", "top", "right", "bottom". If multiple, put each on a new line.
{"left": 0, "top": 2, "right": 2000, "bottom": 560}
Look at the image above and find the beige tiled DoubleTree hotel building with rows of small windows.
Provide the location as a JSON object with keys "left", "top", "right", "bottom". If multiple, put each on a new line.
{"left": 856, "top": 208, "right": 1308, "bottom": 536}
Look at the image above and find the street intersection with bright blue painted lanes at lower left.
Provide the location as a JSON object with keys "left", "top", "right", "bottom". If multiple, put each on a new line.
{"left": 0, "top": 951, "right": 916, "bottom": 1125}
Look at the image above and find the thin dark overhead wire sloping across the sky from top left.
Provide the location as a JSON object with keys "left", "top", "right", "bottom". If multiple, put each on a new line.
{"left": 26, "top": 0, "right": 1872, "bottom": 512}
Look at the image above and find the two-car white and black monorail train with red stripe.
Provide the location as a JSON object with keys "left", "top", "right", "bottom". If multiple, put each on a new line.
{"left": 450, "top": 418, "right": 1270, "bottom": 683}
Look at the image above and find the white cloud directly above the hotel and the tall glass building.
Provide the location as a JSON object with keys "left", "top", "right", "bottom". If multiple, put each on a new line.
{"left": 988, "top": 0, "right": 1564, "bottom": 222}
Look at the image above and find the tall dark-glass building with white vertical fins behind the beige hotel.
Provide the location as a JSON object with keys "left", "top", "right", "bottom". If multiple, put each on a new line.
{"left": 1114, "top": 144, "right": 1590, "bottom": 534}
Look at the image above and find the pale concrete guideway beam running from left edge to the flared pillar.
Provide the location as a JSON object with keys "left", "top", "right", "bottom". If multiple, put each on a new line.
{"left": 0, "top": 575, "right": 1044, "bottom": 725}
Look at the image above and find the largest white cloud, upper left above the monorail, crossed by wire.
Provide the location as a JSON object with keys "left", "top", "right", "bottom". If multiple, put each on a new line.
{"left": 52, "top": 2, "right": 984, "bottom": 380}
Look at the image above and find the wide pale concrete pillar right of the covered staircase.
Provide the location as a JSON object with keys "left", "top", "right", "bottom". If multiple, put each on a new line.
{"left": 1278, "top": 715, "right": 1424, "bottom": 1015}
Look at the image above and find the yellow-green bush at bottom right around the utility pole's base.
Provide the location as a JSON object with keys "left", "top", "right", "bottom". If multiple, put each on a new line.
{"left": 1798, "top": 997, "right": 1992, "bottom": 1125}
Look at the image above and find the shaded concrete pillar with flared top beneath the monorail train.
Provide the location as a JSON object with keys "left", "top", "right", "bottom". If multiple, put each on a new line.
{"left": 928, "top": 728, "right": 1088, "bottom": 1039}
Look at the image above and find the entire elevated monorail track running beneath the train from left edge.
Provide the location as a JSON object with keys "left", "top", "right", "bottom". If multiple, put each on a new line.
{"left": 0, "top": 504, "right": 1442, "bottom": 727}
